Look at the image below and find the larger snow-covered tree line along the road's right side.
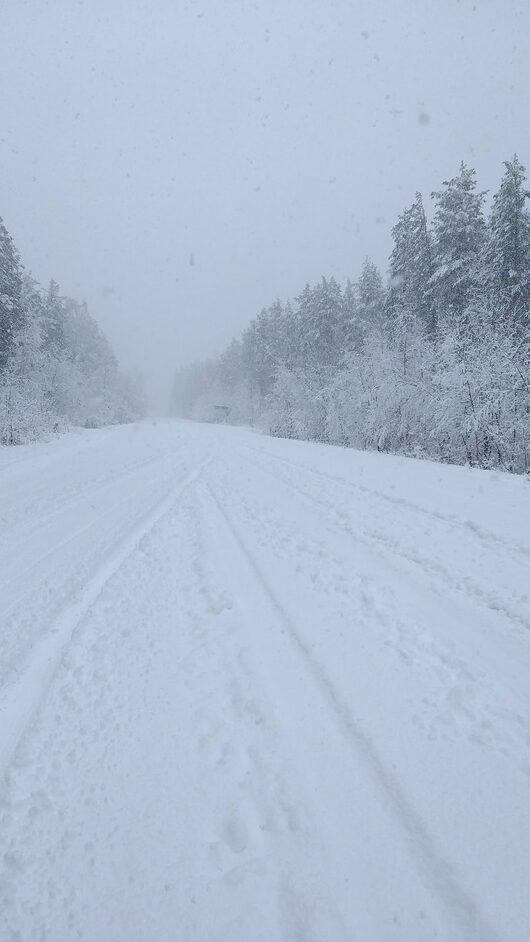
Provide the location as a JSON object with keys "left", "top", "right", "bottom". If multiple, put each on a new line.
{"left": 173, "top": 156, "right": 530, "bottom": 480}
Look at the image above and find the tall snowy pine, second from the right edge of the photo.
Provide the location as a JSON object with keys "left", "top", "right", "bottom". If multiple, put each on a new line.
{"left": 426, "top": 163, "right": 486, "bottom": 323}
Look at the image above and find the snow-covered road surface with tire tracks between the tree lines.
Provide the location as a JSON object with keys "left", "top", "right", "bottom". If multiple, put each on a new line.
{"left": 0, "top": 422, "right": 530, "bottom": 942}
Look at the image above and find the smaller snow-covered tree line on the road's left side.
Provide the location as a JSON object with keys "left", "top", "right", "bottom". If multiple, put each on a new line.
{"left": 0, "top": 217, "right": 145, "bottom": 445}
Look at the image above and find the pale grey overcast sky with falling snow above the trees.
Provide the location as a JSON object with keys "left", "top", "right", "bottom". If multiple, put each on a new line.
{"left": 0, "top": 0, "right": 530, "bottom": 403}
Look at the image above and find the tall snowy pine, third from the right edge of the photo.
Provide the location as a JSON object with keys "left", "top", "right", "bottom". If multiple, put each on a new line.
{"left": 388, "top": 193, "right": 436, "bottom": 339}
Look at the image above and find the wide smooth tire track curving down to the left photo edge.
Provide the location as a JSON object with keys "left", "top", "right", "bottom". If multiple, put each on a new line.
{"left": 0, "top": 455, "right": 212, "bottom": 778}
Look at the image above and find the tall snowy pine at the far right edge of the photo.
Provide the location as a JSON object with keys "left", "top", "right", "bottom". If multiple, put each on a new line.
{"left": 486, "top": 155, "right": 530, "bottom": 331}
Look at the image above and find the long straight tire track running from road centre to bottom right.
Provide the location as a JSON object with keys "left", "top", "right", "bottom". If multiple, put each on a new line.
{"left": 207, "top": 482, "right": 501, "bottom": 942}
